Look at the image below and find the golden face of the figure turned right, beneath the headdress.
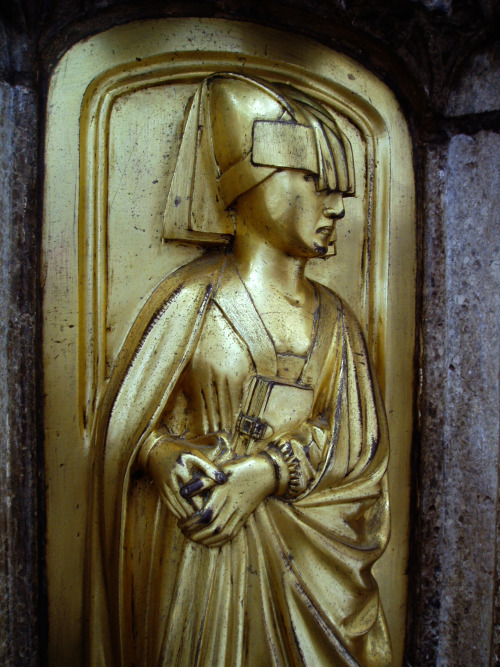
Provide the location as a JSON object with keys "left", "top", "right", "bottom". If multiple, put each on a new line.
{"left": 235, "top": 169, "right": 344, "bottom": 258}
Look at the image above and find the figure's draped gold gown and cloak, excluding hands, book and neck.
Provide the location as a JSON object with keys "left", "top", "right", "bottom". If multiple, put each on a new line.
{"left": 87, "top": 254, "right": 390, "bottom": 667}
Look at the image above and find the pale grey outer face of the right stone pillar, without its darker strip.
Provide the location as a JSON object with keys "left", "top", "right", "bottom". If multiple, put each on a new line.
{"left": 440, "top": 132, "right": 500, "bottom": 665}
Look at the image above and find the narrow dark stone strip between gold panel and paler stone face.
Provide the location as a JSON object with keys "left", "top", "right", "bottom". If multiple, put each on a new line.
{"left": 407, "top": 146, "right": 446, "bottom": 665}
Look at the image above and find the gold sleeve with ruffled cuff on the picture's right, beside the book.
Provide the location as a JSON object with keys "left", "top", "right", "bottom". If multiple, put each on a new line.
{"left": 267, "top": 306, "right": 388, "bottom": 502}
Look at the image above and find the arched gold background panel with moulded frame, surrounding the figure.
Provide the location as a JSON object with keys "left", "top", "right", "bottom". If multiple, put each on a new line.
{"left": 43, "top": 19, "right": 415, "bottom": 665}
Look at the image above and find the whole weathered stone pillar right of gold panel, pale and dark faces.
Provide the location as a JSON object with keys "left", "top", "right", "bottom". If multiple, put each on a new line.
{"left": 415, "top": 132, "right": 500, "bottom": 666}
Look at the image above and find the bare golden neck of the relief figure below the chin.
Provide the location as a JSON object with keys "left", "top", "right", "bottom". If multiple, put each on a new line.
{"left": 233, "top": 229, "right": 309, "bottom": 301}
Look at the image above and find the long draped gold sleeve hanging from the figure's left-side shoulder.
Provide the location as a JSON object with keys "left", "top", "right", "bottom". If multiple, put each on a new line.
{"left": 84, "top": 257, "right": 225, "bottom": 664}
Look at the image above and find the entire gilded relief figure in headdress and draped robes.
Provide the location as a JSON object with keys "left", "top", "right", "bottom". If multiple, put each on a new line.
{"left": 85, "top": 73, "right": 391, "bottom": 667}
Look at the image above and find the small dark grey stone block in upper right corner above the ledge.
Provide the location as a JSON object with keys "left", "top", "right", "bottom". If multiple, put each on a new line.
{"left": 447, "top": 42, "right": 500, "bottom": 116}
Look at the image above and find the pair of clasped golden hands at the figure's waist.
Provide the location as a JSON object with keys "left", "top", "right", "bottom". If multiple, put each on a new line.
{"left": 148, "top": 440, "right": 276, "bottom": 547}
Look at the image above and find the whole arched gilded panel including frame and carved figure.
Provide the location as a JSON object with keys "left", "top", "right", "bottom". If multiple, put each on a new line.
{"left": 43, "top": 19, "right": 415, "bottom": 666}
